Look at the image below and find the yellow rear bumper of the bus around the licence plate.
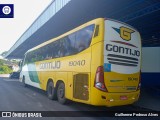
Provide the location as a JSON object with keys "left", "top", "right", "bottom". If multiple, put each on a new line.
{"left": 92, "top": 90, "right": 140, "bottom": 107}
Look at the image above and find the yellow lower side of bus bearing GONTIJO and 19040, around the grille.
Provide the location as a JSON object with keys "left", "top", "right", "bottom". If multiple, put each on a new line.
{"left": 36, "top": 48, "right": 91, "bottom": 102}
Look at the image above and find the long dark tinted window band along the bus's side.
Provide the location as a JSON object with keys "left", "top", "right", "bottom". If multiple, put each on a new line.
{"left": 25, "top": 25, "right": 94, "bottom": 64}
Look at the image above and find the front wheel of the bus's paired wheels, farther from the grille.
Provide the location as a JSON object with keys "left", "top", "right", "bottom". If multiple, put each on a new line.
{"left": 47, "top": 81, "right": 56, "bottom": 100}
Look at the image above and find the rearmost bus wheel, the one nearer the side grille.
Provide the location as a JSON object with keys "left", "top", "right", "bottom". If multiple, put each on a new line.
{"left": 57, "top": 82, "right": 67, "bottom": 104}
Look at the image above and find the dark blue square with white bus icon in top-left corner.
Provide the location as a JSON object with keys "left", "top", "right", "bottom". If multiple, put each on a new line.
{"left": 0, "top": 4, "right": 14, "bottom": 18}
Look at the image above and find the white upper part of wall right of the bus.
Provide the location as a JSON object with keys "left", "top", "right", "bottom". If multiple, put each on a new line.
{"left": 142, "top": 47, "right": 160, "bottom": 72}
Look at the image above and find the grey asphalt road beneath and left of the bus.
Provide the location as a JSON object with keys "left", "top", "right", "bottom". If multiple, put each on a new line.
{"left": 0, "top": 78, "right": 158, "bottom": 120}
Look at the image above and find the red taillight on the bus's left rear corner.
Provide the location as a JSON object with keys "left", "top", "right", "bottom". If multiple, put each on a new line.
{"left": 94, "top": 66, "right": 107, "bottom": 92}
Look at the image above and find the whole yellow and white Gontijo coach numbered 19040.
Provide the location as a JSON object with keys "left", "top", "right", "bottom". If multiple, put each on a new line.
{"left": 20, "top": 18, "right": 141, "bottom": 106}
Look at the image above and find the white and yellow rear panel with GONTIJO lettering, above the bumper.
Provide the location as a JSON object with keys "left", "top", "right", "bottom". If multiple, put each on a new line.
{"left": 104, "top": 20, "right": 141, "bottom": 93}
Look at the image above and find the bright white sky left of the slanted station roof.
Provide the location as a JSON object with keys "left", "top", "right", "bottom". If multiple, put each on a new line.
{"left": 0, "top": 0, "right": 52, "bottom": 54}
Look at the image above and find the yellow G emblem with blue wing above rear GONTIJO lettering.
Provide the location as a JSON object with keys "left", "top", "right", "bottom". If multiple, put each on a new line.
{"left": 112, "top": 26, "right": 135, "bottom": 41}
